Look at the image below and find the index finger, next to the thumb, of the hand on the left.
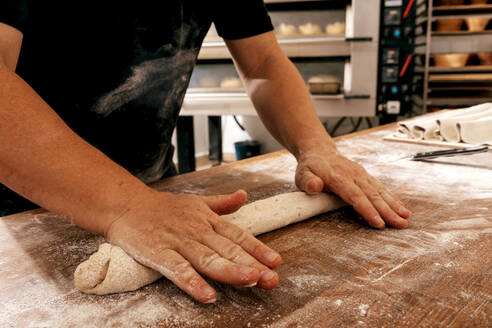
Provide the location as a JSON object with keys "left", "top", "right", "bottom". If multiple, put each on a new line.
{"left": 211, "top": 218, "right": 282, "bottom": 268}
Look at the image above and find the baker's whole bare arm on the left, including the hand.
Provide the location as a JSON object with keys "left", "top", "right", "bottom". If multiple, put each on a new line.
{"left": 0, "top": 23, "right": 281, "bottom": 302}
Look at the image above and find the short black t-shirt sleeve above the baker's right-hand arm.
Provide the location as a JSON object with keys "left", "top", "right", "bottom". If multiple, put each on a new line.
{"left": 214, "top": 0, "right": 273, "bottom": 40}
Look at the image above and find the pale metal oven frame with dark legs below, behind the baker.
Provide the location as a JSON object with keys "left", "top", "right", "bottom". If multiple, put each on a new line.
{"left": 177, "top": 0, "right": 380, "bottom": 173}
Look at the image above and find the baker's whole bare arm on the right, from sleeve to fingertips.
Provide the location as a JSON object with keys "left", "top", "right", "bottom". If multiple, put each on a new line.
{"left": 226, "top": 32, "right": 410, "bottom": 228}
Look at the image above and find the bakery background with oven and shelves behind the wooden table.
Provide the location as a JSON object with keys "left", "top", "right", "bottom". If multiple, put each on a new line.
{"left": 174, "top": 0, "right": 492, "bottom": 172}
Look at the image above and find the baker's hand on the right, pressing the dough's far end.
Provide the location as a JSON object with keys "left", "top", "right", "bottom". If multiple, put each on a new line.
{"left": 296, "top": 143, "right": 411, "bottom": 228}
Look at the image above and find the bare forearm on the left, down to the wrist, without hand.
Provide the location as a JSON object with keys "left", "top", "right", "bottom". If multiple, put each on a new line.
{"left": 0, "top": 64, "right": 153, "bottom": 233}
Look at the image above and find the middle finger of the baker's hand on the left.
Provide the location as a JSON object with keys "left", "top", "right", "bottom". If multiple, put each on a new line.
{"left": 201, "top": 233, "right": 279, "bottom": 289}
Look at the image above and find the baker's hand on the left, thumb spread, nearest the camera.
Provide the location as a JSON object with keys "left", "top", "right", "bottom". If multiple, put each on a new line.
{"left": 106, "top": 190, "right": 282, "bottom": 303}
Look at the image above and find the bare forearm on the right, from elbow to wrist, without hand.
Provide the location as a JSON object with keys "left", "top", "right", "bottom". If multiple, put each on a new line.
{"left": 238, "top": 54, "right": 335, "bottom": 157}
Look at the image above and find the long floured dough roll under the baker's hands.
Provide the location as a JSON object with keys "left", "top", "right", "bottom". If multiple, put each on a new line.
{"left": 74, "top": 192, "right": 346, "bottom": 295}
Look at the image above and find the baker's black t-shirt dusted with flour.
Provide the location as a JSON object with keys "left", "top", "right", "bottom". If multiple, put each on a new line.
{"left": 0, "top": 0, "right": 273, "bottom": 215}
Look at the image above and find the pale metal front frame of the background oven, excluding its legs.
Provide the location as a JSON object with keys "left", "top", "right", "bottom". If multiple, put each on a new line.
{"left": 181, "top": 0, "right": 379, "bottom": 117}
